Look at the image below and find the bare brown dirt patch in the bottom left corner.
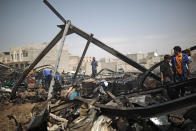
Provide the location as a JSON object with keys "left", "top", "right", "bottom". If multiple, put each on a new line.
{"left": 0, "top": 103, "right": 35, "bottom": 131}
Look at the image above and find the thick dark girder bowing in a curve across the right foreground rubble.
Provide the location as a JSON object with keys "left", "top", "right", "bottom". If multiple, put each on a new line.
{"left": 95, "top": 93, "right": 196, "bottom": 118}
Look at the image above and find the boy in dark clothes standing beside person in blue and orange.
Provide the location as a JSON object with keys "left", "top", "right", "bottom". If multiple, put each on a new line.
{"left": 160, "top": 55, "right": 173, "bottom": 84}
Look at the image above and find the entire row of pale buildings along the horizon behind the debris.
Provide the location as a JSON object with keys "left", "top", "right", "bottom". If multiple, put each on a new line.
{"left": 0, "top": 43, "right": 167, "bottom": 75}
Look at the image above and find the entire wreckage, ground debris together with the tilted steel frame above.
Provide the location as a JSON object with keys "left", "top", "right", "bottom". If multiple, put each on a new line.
{"left": 0, "top": 0, "right": 196, "bottom": 131}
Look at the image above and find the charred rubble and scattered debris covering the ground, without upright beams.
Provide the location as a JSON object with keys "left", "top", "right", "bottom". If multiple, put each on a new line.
{"left": 1, "top": 65, "right": 196, "bottom": 131}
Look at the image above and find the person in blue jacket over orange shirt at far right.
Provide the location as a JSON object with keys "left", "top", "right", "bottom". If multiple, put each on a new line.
{"left": 172, "top": 46, "right": 191, "bottom": 96}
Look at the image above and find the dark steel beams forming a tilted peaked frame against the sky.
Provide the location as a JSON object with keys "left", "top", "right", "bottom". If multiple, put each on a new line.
{"left": 11, "top": 0, "right": 160, "bottom": 99}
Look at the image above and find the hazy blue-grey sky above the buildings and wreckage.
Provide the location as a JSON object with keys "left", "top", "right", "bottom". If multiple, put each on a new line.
{"left": 0, "top": 0, "right": 196, "bottom": 58}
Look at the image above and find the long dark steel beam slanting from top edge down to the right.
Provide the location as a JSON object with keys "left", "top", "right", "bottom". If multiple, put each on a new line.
{"left": 43, "top": 0, "right": 160, "bottom": 81}
